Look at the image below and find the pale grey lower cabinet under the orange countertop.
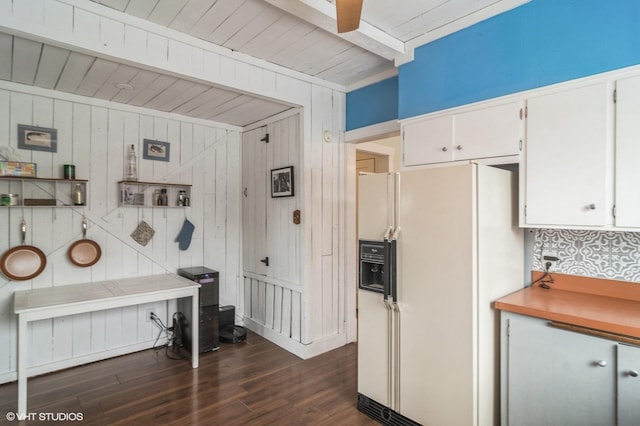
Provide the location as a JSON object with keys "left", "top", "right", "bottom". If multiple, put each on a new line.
{"left": 501, "top": 312, "right": 640, "bottom": 426}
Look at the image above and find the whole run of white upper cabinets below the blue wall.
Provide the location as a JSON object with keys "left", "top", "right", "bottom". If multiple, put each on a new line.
{"left": 402, "top": 66, "right": 640, "bottom": 231}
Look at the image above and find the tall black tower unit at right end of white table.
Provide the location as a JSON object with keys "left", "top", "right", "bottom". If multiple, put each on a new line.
{"left": 178, "top": 266, "right": 220, "bottom": 353}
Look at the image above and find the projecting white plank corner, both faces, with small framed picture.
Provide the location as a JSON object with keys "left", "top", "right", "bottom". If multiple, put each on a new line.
{"left": 243, "top": 87, "right": 355, "bottom": 357}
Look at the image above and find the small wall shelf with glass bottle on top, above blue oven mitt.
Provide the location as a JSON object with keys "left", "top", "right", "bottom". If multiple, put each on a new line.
{"left": 118, "top": 180, "right": 191, "bottom": 208}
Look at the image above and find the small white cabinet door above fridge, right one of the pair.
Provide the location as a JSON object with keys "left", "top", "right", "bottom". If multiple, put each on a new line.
{"left": 453, "top": 101, "right": 523, "bottom": 160}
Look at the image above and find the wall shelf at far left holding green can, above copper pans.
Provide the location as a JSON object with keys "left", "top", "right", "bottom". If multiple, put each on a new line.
{"left": 0, "top": 176, "right": 88, "bottom": 208}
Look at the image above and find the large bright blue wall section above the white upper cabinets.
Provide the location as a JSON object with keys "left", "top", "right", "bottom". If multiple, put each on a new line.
{"left": 398, "top": 0, "right": 640, "bottom": 119}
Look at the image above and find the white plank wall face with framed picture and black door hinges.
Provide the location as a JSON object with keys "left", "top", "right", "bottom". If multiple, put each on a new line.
{"left": 242, "top": 115, "right": 304, "bottom": 342}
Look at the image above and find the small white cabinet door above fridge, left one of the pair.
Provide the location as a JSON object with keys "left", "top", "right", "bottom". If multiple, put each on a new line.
{"left": 402, "top": 115, "right": 453, "bottom": 166}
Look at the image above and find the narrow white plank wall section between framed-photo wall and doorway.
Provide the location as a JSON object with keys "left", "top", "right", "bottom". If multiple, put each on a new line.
{"left": 303, "top": 87, "right": 355, "bottom": 350}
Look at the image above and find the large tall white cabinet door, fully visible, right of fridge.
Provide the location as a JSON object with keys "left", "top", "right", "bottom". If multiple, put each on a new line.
{"left": 521, "top": 83, "right": 612, "bottom": 230}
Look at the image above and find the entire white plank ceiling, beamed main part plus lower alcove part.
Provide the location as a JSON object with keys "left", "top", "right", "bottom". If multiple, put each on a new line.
{"left": 0, "top": 0, "right": 529, "bottom": 126}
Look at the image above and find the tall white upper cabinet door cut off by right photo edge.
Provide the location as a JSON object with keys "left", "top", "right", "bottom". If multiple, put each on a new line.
{"left": 615, "top": 76, "right": 640, "bottom": 227}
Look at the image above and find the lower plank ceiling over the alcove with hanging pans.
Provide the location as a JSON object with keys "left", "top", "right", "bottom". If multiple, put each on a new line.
{"left": 0, "top": 33, "right": 291, "bottom": 127}
